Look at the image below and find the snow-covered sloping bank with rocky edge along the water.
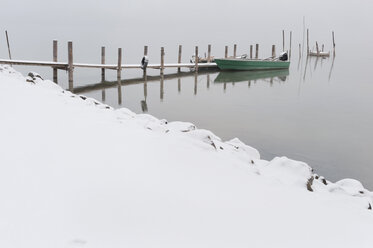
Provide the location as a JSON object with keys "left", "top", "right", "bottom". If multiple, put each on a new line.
{"left": 0, "top": 66, "right": 373, "bottom": 248}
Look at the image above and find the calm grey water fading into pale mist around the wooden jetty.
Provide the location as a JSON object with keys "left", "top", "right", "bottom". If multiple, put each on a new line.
{"left": 0, "top": 0, "right": 373, "bottom": 189}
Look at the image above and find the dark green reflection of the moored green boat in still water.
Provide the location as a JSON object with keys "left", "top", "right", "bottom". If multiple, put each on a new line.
{"left": 214, "top": 69, "right": 289, "bottom": 83}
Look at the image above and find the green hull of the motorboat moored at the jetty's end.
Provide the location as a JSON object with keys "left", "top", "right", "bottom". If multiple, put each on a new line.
{"left": 215, "top": 58, "right": 290, "bottom": 71}
